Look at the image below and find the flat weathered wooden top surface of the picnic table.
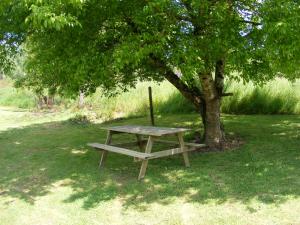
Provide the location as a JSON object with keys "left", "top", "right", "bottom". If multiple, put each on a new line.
{"left": 103, "top": 125, "right": 190, "bottom": 137}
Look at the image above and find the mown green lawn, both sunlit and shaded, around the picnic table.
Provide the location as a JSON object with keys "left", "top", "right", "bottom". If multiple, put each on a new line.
{"left": 0, "top": 110, "right": 300, "bottom": 225}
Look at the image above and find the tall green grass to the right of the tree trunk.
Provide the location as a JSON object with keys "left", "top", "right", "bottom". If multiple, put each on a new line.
{"left": 222, "top": 79, "right": 300, "bottom": 114}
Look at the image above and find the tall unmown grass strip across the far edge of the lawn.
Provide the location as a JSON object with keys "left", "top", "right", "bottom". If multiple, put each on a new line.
{"left": 0, "top": 79, "right": 300, "bottom": 119}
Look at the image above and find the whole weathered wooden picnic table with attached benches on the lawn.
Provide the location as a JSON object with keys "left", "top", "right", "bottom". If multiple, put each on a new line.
{"left": 88, "top": 126, "right": 205, "bottom": 180}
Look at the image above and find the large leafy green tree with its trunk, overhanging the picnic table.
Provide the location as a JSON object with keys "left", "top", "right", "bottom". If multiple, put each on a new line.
{"left": 2, "top": 0, "right": 300, "bottom": 148}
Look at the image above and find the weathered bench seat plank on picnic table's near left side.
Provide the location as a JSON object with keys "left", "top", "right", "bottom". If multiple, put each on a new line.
{"left": 88, "top": 143, "right": 152, "bottom": 159}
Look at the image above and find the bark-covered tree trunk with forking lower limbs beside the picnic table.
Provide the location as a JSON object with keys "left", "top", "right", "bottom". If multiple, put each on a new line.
{"left": 150, "top": 55, "right": 225, "bottom": 150}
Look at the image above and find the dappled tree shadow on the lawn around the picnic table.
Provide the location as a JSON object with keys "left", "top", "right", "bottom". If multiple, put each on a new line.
{"left": 0, "top": 114, "right": 300, "bottom": 210}
